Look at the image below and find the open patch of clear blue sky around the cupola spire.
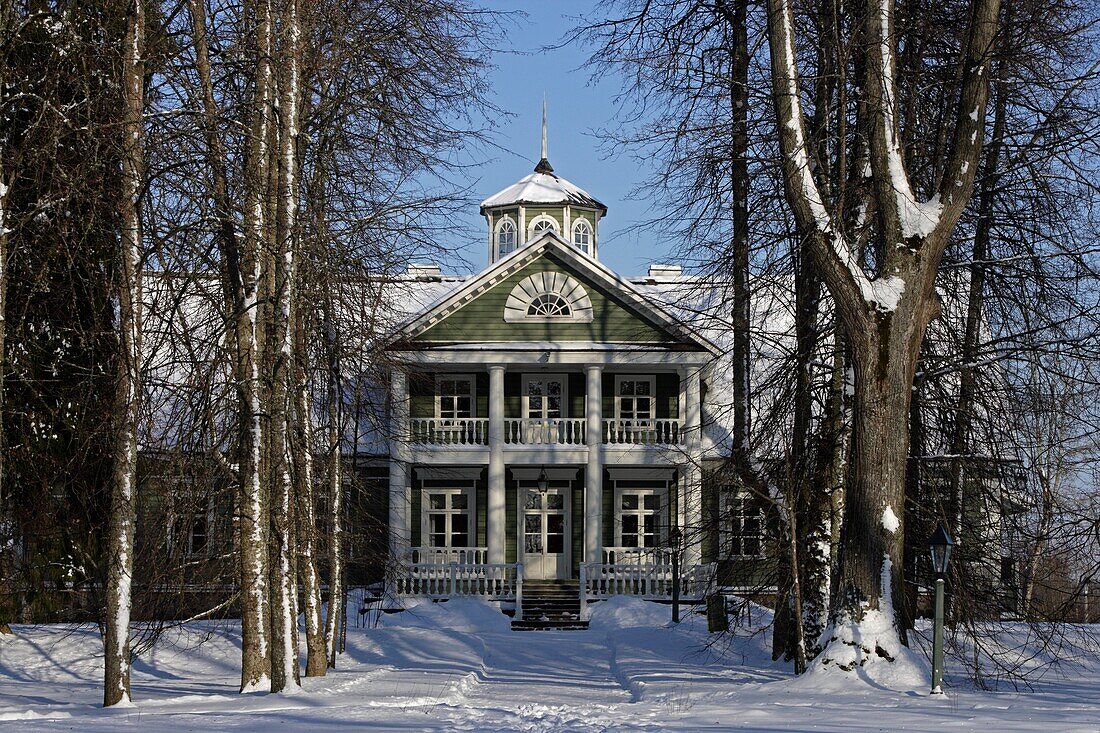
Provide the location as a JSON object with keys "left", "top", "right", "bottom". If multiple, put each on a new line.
{"left": 451, "top": 0, "right": 670, "bottom": 275}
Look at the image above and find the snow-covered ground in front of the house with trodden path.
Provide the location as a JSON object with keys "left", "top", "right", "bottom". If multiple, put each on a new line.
{"left": 0, "top": 599, "right": 1100, "bottom": 733}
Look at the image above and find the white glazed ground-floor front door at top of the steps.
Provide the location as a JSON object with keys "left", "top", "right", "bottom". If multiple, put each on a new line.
{"left": 519, "top": 485, "right": 572, "bottom": 579}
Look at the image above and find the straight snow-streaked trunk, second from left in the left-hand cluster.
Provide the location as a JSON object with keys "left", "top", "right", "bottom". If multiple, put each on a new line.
{"left": 267, "top": 0, "right": 308, "bottom": 692}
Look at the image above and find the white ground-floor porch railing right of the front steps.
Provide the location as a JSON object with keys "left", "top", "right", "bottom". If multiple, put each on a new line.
{"left": 581, "top": 562, "right": 715, "bottom": 602}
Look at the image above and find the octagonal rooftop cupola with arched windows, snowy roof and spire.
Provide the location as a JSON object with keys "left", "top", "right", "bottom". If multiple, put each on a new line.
{"left": 481, "top": 101, "right": 607, "bottom": 264}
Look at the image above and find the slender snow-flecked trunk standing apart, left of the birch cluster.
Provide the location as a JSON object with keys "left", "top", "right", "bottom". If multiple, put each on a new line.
{"left": 103, "top": 0, "right": 145, "bottom": 708}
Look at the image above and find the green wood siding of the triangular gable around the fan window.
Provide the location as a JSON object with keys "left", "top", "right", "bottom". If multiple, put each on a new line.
{"left": 416, "top": 253, "right": 674, "bottom": 346}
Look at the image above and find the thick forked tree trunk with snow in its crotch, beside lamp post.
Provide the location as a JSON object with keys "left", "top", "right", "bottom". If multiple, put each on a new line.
{"left": 768, "top": 0, "right": 999, "bottom": 670}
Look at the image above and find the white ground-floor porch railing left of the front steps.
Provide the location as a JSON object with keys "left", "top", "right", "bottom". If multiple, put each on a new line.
{"left": 396, "top": 562, "right": 524, "bottom": 603}
